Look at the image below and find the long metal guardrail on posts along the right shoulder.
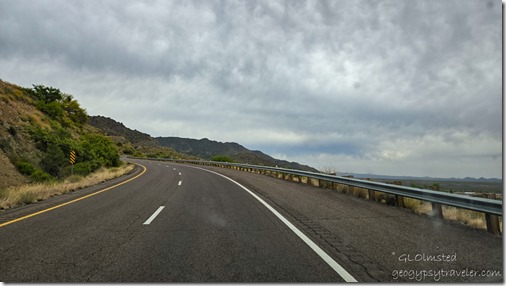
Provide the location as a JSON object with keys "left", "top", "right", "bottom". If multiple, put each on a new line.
{"left": 134, "top": 158, "right": 503, "bottom": 233}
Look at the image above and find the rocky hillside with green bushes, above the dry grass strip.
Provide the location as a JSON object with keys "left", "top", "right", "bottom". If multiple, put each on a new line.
{"left": 0, "top": 80, "right": 121, "bottom": 191}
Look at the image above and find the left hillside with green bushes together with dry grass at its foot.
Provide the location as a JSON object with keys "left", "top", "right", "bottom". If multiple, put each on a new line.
{"left": 0, "top": 80, "right": 133, "bottom": 209}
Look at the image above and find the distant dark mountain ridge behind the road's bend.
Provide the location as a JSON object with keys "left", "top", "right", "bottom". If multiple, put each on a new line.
{"left": 89, "top": 115, "right": 318, "bottom": 172}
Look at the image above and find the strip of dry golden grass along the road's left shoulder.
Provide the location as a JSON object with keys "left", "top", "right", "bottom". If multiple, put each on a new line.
{"left": 0, "top": 164, "right": 134, "bottom": 209}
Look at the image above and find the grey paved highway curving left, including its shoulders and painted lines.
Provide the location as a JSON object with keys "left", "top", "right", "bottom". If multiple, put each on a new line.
{"left": 0, "top": 161, "right": 503, "bottom": 283}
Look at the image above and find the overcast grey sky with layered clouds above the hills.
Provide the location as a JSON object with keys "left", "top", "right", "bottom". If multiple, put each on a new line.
{"left": 0, "top": 0, "right": 502, "bottom": 178}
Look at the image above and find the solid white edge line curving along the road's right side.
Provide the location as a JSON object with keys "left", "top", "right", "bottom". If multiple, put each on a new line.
{"left": 188, "top": 166, "right": 358, "bottom": 282}
